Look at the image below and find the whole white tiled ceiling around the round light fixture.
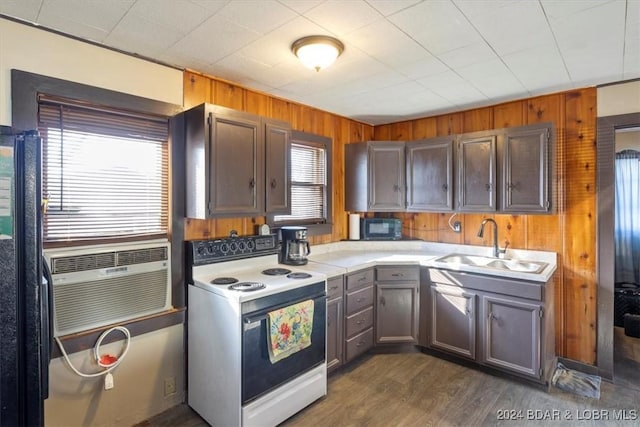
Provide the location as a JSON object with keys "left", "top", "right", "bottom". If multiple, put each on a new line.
{"left": 0, "top": 0, "right": 640, "bottom": 124}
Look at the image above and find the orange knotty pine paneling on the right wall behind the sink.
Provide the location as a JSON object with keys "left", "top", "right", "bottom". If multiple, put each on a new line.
{"left": 374, "top": 88, "right": 597, "bottom": 364}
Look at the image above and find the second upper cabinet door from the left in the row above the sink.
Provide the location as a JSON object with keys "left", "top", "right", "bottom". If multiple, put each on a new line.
{"left": 405, "top": 137, "right": 455, "bottom": 212}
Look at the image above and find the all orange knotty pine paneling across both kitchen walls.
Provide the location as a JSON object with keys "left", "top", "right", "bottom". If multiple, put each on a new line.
{"left": 184, "top": 71, "right": 597, "bottom": 364}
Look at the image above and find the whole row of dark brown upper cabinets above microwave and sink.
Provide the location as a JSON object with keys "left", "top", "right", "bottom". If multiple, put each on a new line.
{"left": 345, "top": 123, "right": 554, "bottom": 214}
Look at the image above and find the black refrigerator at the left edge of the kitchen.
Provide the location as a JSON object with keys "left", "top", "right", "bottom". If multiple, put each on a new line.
{"left": 0, "top": 126, "right": 51, "bottom": 427}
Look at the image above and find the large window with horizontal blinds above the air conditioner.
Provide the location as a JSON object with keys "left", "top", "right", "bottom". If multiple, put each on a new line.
{"left": 38, "top": 97, "right": 169, "bottom": 242}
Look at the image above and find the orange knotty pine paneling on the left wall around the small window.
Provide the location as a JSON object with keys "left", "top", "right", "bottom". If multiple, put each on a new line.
{"left": 184, "top": 71, "right": 373, "bottom": 244}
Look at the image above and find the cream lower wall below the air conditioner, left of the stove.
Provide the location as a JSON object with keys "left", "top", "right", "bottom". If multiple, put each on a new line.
{"left": 45, "top": 325, "right": 185, "bottom": 427}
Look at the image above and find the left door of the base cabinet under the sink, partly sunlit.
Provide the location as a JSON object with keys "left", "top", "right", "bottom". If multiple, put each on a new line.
{"left": 430, "top": 284, "right": 476, "bottom": 360}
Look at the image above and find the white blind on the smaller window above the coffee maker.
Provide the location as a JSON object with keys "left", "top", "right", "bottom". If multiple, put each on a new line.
{"left": 274, "top": 143, "right": 327, "bottom": 224}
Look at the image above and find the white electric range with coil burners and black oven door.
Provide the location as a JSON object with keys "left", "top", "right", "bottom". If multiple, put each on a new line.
{"left": 187, "top": 235, "right": 327, "bottom": 427}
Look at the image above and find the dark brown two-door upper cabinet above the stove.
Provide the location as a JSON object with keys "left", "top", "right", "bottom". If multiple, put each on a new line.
{"left": 182, "top": 104, "right": 291, "bottom": 218}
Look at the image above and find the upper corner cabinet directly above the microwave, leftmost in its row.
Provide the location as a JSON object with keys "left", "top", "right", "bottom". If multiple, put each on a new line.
{"left": 345, "top": 141, "right": 406, "bottom": 212}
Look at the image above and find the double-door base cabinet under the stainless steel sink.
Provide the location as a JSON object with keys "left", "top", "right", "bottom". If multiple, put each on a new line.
{"left": 421, "top": 268, "right": 555, "bottom": 382}
